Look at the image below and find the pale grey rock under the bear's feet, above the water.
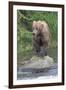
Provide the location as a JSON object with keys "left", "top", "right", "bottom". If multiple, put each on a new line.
{"left": 22, "top": 56, "right": 54, "bottom": 69}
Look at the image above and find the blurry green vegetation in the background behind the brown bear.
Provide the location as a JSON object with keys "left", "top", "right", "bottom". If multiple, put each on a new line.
{"left": 17, "top": 10, "right": 58, "bottom": 64}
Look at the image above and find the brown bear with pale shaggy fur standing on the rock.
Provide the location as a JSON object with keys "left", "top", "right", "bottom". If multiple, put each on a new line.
{"left": 32, "top": 21, "right": 50, "bottom": 56}
